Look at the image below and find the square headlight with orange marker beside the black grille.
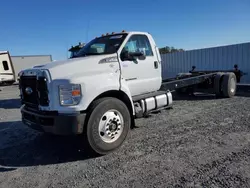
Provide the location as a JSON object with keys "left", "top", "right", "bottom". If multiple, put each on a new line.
{"left": 59, "top": 84, "right": 82, "bottom": 106}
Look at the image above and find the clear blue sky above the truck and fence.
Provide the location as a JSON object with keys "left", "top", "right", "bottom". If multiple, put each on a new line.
{"left": 0, "top": 0, "right": 250, "bottom": 60}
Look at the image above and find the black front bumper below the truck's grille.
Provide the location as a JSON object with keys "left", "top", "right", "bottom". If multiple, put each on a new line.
{"left": 21, "top": 105, "right": 86, "bottom": 135}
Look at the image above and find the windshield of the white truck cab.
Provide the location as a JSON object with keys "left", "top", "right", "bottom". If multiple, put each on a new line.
{"left": 73, "top": 33, "right": 127, "bottom": 58}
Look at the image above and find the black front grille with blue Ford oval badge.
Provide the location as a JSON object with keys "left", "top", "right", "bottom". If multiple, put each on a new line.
{"left": 19, "top": 76, "right": 49, "bottom": 107}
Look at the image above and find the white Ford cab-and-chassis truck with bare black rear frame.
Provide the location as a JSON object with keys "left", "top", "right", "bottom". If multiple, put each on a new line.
{"left": 19, "top": 31, "right": 240, "bottom": 155}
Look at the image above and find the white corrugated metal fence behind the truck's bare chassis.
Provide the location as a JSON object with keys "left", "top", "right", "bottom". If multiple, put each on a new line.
{"left": 161, "top": 42, "right": 250, "bottom": 84}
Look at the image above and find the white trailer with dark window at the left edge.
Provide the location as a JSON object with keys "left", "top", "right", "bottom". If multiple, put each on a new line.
{"left": 0, "top": 51, "right": 16, "bottom": 85}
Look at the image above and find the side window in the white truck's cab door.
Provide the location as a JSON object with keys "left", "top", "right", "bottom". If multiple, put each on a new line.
{"left": 122, "top": 35, "right": 153, "bottom": 56}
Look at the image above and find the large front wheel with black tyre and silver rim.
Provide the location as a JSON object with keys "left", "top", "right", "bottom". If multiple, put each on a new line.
{"left": 86, "top": 98, "right": 131, "bottom": 155}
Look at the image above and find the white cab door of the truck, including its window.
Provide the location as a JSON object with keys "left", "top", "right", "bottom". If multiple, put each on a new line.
{"left": 119, "top": 34, "right": 162, "bottom": 96}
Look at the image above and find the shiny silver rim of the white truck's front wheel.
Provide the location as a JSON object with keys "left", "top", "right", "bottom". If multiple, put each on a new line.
{"left": 99, "top": 109, "right": 124, "bottom": 143}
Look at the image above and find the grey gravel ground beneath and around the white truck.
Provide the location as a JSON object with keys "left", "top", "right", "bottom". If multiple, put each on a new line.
{"left": 0, "top": 86, "right": 250, "bottom": 188}
